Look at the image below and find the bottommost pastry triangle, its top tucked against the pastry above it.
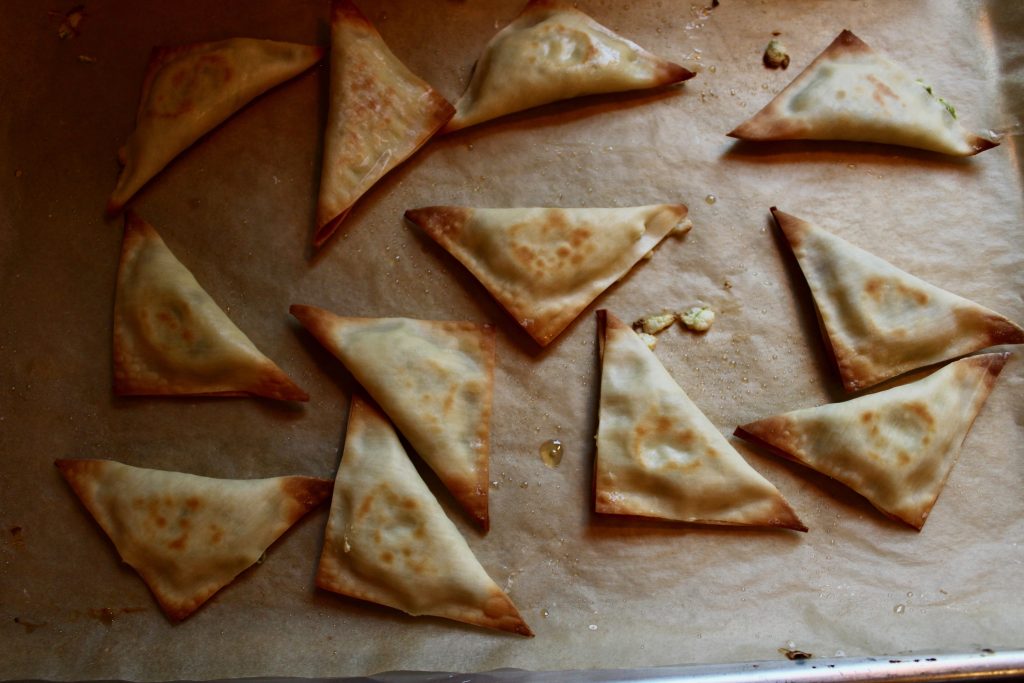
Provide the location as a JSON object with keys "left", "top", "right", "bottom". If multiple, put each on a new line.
{"left": 316, "top": 396, "right": 534, "bottom": 636}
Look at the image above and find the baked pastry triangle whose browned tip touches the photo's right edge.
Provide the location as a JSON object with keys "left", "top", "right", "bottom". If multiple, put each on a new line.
{"left": 772, "top": 207, "right": 1024, "bottom": 391}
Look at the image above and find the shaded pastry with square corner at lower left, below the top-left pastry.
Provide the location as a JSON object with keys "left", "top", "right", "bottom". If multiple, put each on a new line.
{"left": 114, "top": 211, "right": 309, "bottom": 400}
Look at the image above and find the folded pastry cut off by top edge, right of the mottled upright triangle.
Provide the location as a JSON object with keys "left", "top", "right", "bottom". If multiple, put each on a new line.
{"left": 444, "top": 0, "right": 694, "bottom": 132}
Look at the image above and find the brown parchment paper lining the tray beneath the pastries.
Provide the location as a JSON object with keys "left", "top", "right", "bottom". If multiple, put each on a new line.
{"left": 0, "top": 0, "right": 1024, "bottom": 680}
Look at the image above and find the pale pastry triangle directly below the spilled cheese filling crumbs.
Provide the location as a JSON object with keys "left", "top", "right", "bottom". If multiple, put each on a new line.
{"left": 594, "top": 311, "right": 807, "bottom": 531}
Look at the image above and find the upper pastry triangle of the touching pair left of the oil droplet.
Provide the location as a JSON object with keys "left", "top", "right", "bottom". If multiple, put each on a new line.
{"left": 291, "top": 305, "right": 495, "bottom": 529}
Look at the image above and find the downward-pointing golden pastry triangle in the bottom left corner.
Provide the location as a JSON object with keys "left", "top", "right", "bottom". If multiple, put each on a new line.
{"left": 56, "top": 460, "right": 331, "bottom": 620}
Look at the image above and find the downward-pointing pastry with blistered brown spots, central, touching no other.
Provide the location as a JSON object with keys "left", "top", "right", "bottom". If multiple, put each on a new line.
{"left": 406, "top": 204, "right": 692, "bottom": 346}
